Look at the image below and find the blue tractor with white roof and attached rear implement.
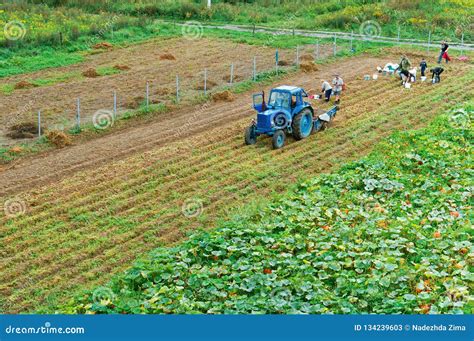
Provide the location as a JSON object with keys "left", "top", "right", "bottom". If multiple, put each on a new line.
{"left": 245, "top": 85, "right": 338, "bottom": 149}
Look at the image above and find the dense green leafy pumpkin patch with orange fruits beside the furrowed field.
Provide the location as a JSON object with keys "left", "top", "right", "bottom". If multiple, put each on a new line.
{"left": 62, "top": 111, "right": 474, "bottom": 314}
